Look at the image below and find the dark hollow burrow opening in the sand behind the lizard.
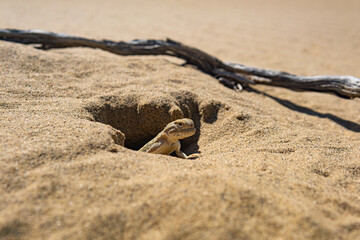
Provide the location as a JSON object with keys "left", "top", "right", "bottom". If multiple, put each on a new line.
{"left": 85, "top": 89, "right": 225, "bottom": 151}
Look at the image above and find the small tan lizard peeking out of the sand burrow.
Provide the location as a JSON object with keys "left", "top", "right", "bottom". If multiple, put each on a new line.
{"left": 139, "top": 118, "right": 200, "bottom": 159}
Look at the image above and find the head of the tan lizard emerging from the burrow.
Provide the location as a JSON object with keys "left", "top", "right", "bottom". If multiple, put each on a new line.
{"left": 164, "top": 118, "right": 196, "bottom": 141}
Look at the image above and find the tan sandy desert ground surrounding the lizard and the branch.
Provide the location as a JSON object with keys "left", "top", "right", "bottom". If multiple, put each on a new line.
{"left": 0, "top": 0, "right": 360, "bottom": 239}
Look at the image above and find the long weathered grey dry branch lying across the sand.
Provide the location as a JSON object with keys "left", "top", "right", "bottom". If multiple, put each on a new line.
{"left": 0, "top": 29, "right": 360, "bottom": 98}
